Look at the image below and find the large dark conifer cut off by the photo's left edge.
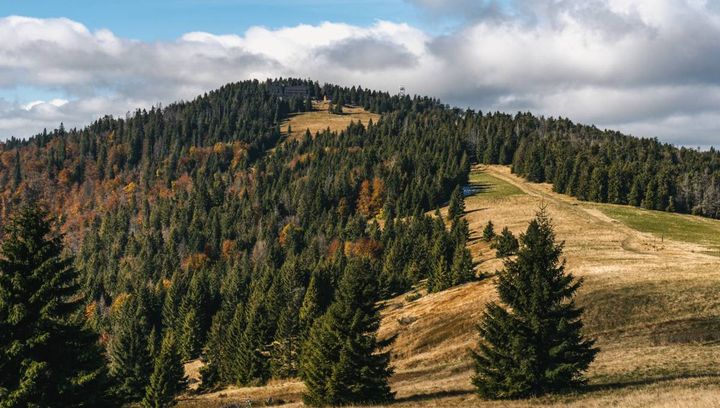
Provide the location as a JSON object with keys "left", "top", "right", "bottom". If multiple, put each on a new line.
{"left": 0, "top": 204, "right": 114, "bottom": 408}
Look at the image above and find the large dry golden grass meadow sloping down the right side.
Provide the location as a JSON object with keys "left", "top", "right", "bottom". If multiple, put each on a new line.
{"left": 183, "top": 166, "right": 720, "bottom": 407}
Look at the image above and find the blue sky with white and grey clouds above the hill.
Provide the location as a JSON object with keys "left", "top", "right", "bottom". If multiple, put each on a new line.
{"left": 0, "top": 0, "right": 720, "bottom": 148}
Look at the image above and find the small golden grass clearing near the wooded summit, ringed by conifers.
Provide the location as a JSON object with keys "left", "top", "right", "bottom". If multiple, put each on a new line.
{"left": 280, "top": 101, "right": 380, "bottom": 140}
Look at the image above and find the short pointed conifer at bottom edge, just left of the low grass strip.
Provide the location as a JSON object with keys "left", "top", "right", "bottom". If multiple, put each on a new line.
{"left": 141, "top": 331, "right": 186, "bottom": 408}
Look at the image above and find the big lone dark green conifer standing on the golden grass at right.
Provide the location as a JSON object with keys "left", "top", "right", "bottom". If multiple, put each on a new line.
{"left": 472, "top": 210, "right": 597, "bottom": 399}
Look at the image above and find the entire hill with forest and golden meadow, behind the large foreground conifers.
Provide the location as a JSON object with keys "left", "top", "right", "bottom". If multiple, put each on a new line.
{"left": 0, "top": 79, "right": 720, "bottom": 406}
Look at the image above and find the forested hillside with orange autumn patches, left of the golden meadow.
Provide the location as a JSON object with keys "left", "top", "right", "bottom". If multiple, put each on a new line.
{"left": 0, "top": 80, "right": 472, "bottom": 402}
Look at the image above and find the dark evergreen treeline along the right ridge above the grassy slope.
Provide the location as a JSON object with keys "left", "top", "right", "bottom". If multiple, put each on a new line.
{"left": 467, "top": 113, "right": 720, "bottom": 218}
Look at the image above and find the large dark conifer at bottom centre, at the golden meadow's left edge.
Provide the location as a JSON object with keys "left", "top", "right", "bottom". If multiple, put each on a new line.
{"left": 301, "top": 259, "right": 393, "bottom": 406}
